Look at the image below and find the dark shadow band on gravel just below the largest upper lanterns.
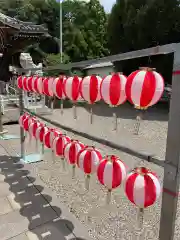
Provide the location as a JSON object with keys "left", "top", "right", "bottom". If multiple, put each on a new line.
{"left": 84, "top": 102, "right": 169, "bottom": 121}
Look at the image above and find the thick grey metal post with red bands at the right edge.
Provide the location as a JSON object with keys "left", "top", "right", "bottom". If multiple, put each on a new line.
{"left": 159, "top": 49, "right": 180, "bottom": 240}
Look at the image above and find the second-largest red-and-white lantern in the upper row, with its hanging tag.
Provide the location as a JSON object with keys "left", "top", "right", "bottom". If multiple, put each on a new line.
{"left": 100, "top": 73, "right": 127, "bottom": 130}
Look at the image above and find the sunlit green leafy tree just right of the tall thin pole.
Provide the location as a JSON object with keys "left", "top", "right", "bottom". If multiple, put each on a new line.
{"left": 63, "top": 0, "right": 108, "bottom": 61}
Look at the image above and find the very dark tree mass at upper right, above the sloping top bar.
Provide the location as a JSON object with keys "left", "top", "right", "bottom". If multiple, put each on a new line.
{"left": 108, "top": 0, "right": 180, "bottom": 53}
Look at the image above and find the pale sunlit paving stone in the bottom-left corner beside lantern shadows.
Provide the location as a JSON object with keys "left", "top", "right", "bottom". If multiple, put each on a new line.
{"left": 0, "top": 211, "right": 29, "bottom": 240}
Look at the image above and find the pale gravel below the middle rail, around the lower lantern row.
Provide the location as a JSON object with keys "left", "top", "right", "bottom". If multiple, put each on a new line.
{"left": 2, "top": 126, "right": 167, "bottom": 240}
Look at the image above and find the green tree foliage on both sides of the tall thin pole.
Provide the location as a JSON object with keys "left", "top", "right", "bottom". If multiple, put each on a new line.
{"left": 0, "top": 0, "right": 109, "bottom": 64}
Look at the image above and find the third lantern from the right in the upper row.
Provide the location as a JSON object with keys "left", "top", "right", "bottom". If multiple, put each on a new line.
{"left": 80, "top": 75, "right": 102, "bottom": 104}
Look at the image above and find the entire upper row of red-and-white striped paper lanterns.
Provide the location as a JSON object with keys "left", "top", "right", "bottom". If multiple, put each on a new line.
{"left": 18, "top": 68, "right": 164, "bottom": 109}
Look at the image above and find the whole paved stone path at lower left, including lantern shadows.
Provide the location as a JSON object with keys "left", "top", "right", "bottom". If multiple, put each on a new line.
{"left": 0, "top": 132, "right": 90, "bottom": 240}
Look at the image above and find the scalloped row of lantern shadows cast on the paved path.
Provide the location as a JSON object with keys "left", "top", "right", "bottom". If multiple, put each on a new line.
{"left": 0, "top": 156, "right": 88, "bottom": 240}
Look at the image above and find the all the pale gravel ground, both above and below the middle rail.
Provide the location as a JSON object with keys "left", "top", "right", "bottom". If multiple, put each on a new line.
{"left": 3, "top": 105, "right": 180, "bottom": 240}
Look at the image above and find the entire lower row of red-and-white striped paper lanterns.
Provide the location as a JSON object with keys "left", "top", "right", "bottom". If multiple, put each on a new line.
{"left": 19, "top": 113, "right": 161, "bottom": 208}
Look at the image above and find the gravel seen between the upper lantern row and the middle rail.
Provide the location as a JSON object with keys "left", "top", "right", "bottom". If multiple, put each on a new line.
{"left": 44, "top": 104, "right": 168, "bottom": 160}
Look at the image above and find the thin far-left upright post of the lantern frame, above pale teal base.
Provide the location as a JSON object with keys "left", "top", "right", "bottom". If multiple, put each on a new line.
{"left": 19, "top": 89, "right": 25, "bottom": 160}
